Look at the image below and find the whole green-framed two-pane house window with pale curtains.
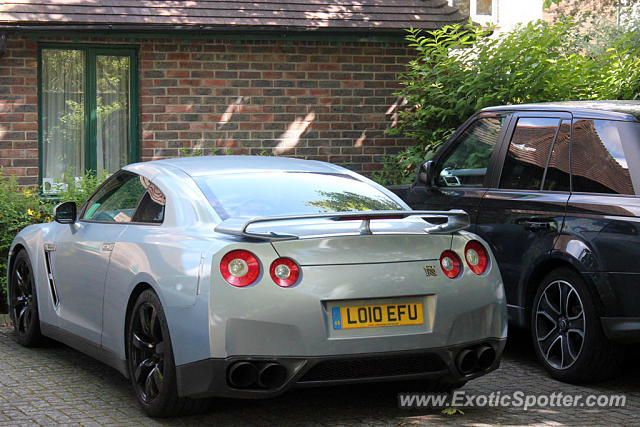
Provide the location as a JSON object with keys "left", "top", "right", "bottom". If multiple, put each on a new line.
{"left": 38, "top": 45, "right": 138, "bottom": 192}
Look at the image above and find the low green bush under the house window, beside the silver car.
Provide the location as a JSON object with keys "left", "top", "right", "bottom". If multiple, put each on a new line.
{"left": 0, "top": 170, "right": 106, "bottom": 313}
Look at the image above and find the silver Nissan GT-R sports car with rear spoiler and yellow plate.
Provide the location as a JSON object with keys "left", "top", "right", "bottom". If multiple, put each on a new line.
{"left": 8, "top": 156, "right": 507, "bottom": 416}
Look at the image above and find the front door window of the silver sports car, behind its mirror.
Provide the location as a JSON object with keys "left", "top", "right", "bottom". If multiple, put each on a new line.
{"left": 82, "top": 172, "right": 146, "bottom": 222}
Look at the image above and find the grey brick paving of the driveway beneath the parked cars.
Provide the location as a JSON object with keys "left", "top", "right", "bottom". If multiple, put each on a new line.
{"left": 0, "top": 327, "right": 640, "bottom": 426}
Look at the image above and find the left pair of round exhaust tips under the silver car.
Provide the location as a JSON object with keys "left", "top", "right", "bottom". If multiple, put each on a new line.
{"left": 227, "top": 361, "right": 288, "bottom": 390}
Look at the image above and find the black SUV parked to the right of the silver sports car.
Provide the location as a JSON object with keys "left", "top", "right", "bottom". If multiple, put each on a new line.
{"left": 392, "top": 101, "right": 640, "bottom": 381}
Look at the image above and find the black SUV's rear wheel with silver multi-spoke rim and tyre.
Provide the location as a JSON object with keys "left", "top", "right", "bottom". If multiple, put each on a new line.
{"left": 531, "top": 268, "right": 623, "bottom": 382}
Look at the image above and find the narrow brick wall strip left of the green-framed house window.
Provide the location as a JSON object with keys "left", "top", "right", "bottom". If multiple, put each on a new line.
{"left": 0, "top": 37, "right": 38, "bottom": 184}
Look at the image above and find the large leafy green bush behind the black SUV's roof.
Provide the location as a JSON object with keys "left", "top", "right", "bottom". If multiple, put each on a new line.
{"left": 374, "top": 20, "right": 640, "bottom": 185}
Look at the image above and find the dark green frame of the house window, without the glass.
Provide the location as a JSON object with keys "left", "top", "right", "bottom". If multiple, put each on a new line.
{"left": 38, "top": 43, "right": 140, "bottom": 191}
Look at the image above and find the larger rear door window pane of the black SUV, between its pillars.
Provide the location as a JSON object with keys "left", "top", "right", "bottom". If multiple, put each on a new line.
{"left": 500, "top": 117, "right": 560, "bottom": 190}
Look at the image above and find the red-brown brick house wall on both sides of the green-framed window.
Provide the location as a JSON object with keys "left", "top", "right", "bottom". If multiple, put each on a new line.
{"left": 0, "top": 35, "right": 412, "bottom": 184}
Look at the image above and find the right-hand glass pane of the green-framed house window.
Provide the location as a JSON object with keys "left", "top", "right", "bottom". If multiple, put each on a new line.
{"left": 96, "top": 55, "right": 130, "bottom": 173}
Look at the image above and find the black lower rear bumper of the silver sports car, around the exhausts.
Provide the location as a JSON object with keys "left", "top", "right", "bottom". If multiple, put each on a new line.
{"left": 176, "top": 338, "right": 506, "bottom": 399}
